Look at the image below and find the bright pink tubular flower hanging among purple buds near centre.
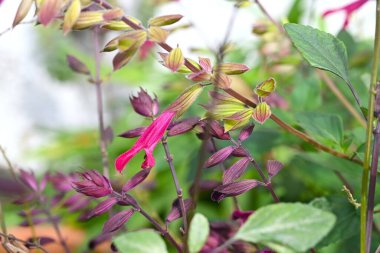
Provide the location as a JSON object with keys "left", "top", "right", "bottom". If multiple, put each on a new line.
{"left": 115, "top": 110, "right": 176, "bottom": 172}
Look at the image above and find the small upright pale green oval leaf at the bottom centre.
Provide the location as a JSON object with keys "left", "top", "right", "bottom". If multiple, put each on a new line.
{"left": 189, "top": 213, "right": 210, "bottom": 253}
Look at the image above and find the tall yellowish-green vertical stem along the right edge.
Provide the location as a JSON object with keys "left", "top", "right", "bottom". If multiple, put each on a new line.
{"left": 360, "top": 0, "right": 380, "bottom": 253}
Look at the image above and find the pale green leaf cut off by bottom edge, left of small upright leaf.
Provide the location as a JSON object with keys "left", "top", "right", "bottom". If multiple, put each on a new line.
{"left": 113, "top": 230, "right": 168, "bottom": 253}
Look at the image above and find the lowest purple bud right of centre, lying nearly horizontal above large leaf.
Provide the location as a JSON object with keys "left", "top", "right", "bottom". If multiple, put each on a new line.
{"left": 211, "top": 179, "right": 262, "bottom": 202}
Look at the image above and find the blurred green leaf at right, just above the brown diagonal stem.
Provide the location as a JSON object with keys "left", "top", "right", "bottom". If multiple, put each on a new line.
{"left": 296, "top": 112, "right": 343, "bottom": 147}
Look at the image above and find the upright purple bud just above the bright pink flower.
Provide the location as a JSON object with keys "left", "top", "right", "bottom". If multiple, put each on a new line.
{"left": 130, "top": 88, "right": 159, "bottom": 117}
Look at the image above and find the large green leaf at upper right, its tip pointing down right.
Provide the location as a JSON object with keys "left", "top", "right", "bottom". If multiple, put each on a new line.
{"left": 284, "top": 23, "right": 350, "bottom": 84}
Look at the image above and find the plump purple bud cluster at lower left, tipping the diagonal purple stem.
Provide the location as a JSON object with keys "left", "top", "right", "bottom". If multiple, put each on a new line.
{"left": 73, "top": 170, "right": 113, "bottom": 198}
